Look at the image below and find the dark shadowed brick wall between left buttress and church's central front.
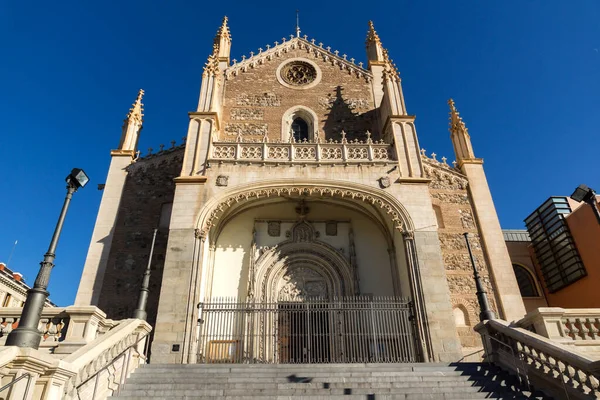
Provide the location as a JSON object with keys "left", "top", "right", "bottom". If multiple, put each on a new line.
{"left": 98, "top": 147, "right": 183, "bottom": 325}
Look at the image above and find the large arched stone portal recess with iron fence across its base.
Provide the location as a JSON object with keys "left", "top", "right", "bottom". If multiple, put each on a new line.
{"left": 188, "top": 181, "right": 422, "bottom": 362}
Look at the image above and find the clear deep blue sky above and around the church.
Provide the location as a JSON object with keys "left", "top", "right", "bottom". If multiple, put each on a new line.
{"left": 0, "top": 0, "right": 600, "bottom": 305}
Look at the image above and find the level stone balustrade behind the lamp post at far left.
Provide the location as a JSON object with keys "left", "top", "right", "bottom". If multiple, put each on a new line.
{"left": 0, "top": 306, "right": 116, "bottom": 354}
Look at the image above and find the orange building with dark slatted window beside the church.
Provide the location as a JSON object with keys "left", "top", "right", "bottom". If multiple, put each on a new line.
{"left": 520, "top": 197, "right": 600, "bottom": 312}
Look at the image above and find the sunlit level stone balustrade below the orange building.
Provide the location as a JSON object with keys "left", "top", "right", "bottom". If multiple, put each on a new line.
{"left": 517, "top": 307, "right": 600, "bottom": 345}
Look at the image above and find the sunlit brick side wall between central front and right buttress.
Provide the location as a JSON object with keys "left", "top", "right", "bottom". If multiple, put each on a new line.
{"left": 423, "top": 157, "right": 498, "bottom": 347}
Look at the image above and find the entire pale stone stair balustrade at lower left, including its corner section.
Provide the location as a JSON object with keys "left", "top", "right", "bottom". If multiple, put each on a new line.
{"left": 0, "top": 318, "right": 152, "bottom": 400}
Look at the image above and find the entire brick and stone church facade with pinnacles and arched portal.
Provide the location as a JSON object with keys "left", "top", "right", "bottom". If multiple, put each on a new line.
{"left": 76, "top": 19, "right": 525, "bottom": 363}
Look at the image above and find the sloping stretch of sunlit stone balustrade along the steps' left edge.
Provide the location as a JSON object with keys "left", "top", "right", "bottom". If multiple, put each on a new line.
{"left": 63, "top": 319, "right": 152, "bottom": 399}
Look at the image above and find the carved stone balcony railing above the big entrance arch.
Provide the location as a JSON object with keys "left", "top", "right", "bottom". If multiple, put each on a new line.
{"left": 210, "top": 139, "right": 394, "bottom": 164}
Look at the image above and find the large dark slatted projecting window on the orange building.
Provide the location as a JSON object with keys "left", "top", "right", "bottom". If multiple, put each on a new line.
{"left": 525, "top": 197, "right": 587, "bottom": 293}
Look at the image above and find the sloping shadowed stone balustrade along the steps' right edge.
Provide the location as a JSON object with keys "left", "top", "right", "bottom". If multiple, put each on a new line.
{"left": 475, "top": 320, "right": 600, "bottom": 399}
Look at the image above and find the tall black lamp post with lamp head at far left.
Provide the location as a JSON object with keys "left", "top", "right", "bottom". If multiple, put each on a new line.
{"left": 6, "top": 168, "right": 90, "bottom": 349}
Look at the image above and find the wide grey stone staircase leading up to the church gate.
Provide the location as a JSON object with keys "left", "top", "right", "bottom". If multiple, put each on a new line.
{"left": 111, "top": 363, "right": 550, "bottom": 400}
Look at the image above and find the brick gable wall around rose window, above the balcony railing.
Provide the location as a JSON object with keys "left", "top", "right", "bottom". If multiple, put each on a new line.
{"left": 221, "top": 49, "right": 379, "bottom": 140}
